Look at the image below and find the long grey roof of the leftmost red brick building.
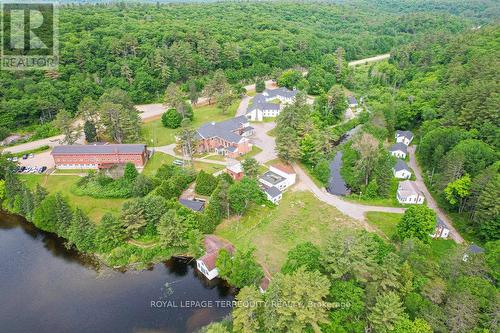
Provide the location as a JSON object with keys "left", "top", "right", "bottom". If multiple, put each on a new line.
{"left": 51, "top": 144, "right": 146, "bottom": 155}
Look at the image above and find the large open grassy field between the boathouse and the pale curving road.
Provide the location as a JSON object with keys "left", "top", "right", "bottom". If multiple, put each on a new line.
{"left": 215, "top": 192, "right": 356, "bottom": 273}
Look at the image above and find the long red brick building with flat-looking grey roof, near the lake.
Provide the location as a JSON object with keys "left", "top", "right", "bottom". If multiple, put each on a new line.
{"left": 51, "top": 144, "right": 148, "bottom": 169}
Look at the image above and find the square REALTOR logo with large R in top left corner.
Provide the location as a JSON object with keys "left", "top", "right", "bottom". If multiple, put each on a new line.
{"left": 0, "top": 1, "right": 59, "bottom": 70}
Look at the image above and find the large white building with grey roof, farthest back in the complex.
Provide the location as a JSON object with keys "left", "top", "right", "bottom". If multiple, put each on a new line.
{"left": 246, "top": 88, "right": 297, "bottom": 121}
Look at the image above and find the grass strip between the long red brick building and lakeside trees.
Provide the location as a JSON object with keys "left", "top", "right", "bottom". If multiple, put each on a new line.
{"left": 19, "top": 175, "right": 126, "bottom": 222}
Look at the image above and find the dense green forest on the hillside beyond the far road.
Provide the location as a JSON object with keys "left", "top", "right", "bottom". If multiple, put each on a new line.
{"left": 0, "top": 2, "right": 472, "bottom": 136}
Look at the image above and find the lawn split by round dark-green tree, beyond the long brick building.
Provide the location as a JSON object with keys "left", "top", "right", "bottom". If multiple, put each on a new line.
{"left": 141, "top": 100, "right": 240, "bottom": 146}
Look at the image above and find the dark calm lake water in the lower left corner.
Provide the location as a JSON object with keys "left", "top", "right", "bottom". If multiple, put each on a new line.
{"left": 0, "top": 212, "right": 234, "bottom": 333}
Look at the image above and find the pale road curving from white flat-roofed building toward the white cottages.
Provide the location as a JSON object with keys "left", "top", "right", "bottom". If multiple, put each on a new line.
{"left": 293, "top": 164, "right": 405, "bottom": 224}
